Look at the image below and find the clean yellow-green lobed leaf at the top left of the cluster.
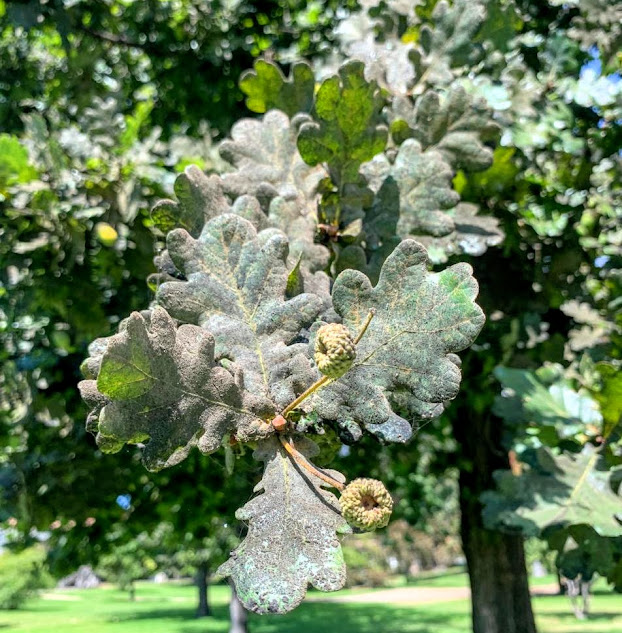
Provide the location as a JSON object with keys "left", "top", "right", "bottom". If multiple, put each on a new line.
{"left": 239, "top": 59, "right": 315, "bottom": 116}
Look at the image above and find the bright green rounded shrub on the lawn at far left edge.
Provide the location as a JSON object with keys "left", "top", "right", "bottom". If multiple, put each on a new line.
{"left": 0, "top": 547, "right": 52, "bottom": 609}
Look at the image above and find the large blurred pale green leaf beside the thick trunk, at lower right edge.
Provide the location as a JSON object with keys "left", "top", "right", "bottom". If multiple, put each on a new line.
{"left": 482, "top": 444, "right": 622, "bottom": 537}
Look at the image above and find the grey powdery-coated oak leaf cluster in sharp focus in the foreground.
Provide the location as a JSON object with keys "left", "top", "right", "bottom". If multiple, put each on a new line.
{"left": 81, "top": 47, "right": 492, "bottom": 612}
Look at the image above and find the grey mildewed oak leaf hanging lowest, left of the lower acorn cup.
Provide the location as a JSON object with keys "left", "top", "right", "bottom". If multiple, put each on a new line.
{"left": 218, "top": 439, "right": 349, "bottom": 614}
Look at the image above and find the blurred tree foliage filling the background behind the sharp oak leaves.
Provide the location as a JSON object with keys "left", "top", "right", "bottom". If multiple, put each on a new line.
{"left": 0, "top": 0, "right": 622, "bottom": 624}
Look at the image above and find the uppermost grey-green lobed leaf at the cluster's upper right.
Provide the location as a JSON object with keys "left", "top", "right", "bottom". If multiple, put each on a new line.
{"left": 390, "top": 86, "right": 500, "bottom": 171}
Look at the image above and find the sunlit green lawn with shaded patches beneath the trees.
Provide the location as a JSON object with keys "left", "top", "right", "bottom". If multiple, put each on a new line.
{"left": 0, "top": 579, "right": 622, "bottom": 633}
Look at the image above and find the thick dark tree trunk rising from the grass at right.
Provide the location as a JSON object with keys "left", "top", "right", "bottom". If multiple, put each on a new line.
{"left": 454, "top": 408, "right": 536, "bottom": 633}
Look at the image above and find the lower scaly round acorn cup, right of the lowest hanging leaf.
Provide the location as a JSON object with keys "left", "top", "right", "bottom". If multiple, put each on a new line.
{"left": 339, "top": 479, "right": 393, "bottom": 531}
